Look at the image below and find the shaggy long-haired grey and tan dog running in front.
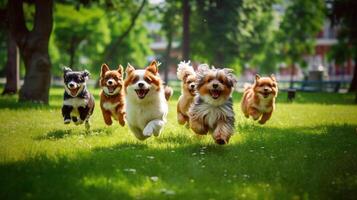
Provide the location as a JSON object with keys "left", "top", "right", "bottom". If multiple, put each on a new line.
{"left": 189, "top": 65, "right": 237, "bottom": 144}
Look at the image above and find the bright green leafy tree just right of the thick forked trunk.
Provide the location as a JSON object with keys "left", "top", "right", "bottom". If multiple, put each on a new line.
{"left": 51, "top": 4, "right": 110, "bottom": 71}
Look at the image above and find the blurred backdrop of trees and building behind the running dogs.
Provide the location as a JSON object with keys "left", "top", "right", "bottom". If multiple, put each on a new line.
{"left": 0, "top": 0, "right": 357, "bottom": 103}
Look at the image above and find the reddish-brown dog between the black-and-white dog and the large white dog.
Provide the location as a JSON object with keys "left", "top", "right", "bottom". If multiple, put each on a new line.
{"left": 100, "top": 64, "right": 125, "bottom": 126}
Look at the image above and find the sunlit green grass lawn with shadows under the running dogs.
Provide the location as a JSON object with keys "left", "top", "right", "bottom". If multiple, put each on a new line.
{"left": 0, "top": 89, "right": 357, "bottom": 199}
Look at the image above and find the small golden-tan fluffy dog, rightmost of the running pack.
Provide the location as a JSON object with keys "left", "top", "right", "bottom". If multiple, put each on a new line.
{"left": 241, "top": 74, "right": 278, "bottom": 124}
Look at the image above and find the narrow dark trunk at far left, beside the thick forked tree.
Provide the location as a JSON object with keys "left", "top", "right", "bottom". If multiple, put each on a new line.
{"left": 2, "top": 32, "right": 20, "bottom": 95}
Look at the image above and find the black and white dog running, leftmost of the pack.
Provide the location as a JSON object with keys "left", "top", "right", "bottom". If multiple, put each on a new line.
{"left": 62, "top": 67, "right": 94, "bottom": 129}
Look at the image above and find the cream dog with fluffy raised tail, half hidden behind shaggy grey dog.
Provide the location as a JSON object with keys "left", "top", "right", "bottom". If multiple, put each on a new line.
{"left": 177, "top": 61, "right": 196, "bottom": 128}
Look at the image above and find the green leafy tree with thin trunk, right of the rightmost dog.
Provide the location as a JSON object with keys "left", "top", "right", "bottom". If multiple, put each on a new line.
{"left": 277, "top": 0, "right": 325, "bottom": 88}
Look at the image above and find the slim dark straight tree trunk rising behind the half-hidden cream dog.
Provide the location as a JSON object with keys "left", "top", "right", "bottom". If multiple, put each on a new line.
{"left": 182, "top": 0, "right": 190, "bottom": 61}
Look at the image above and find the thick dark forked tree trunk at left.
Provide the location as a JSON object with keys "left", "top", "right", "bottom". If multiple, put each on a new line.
{"left": 7, "top": 0, "right": 53, "bottom": 104}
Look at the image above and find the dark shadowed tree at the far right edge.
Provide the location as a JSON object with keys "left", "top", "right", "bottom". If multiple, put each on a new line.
{"left": 327, "top": 0, "right": 357, "bottom": 93}
